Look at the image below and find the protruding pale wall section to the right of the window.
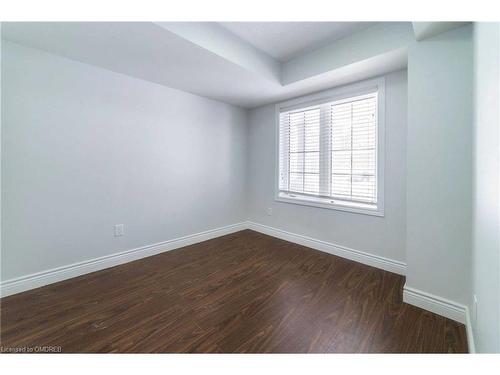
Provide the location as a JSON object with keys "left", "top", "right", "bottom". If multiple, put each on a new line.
{"left": 406, "top": 26, "right": 472, "bottom": 304}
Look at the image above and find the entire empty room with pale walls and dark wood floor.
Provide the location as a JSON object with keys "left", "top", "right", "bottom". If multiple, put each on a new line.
{"left": 0, "top": 4, "right": 500, "bottom": 364}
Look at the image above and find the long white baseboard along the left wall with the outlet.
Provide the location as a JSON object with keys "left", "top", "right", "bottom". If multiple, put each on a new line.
{"left": 0, "top": 223, "right": 247, "bottom": 297}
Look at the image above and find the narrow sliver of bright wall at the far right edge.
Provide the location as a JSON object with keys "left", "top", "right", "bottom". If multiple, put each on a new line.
{"left": 470, "top": 23, "right": 500, "bottom": 352}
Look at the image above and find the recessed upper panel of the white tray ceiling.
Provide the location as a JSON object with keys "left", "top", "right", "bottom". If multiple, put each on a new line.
{"left": 219, "top": 22, "right": 375, "bottom": 62}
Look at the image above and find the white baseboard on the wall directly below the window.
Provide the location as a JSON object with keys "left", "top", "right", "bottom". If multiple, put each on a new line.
{"left": 248, "top": 221, "right": 406, "bottom": 275}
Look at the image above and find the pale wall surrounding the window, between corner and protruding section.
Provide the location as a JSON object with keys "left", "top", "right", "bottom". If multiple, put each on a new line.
{"left": 247, "top": 71, "right": 407, "bottom": 261}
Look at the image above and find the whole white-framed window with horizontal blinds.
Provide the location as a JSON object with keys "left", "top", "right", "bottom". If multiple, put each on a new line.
{"left": 277, "top": 79, "right": 384, "bottom": 216}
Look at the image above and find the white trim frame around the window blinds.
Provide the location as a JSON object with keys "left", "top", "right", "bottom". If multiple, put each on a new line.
{"left": 274, "top": 77, "right": 385, "bottom": 217}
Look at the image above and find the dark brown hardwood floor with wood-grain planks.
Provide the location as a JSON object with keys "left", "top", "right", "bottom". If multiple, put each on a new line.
{"left": 0, "top": 230, "right": 467, "bottom": 353}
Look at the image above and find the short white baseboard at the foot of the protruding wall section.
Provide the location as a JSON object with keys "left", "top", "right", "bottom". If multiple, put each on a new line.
{"left": 403, "top": 284, "right": 467, "bottom": 324}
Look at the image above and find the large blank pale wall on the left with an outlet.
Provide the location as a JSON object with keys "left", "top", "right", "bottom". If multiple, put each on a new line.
{"left": 2, "top": 41, "right": 247, "bottom": 280}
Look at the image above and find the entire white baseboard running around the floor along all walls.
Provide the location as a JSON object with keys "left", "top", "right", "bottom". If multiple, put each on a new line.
{"left": 0, "top": 221, "right": 475, "bottom": 353}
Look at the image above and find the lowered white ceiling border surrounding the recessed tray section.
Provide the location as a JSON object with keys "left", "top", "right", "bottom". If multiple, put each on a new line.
{"left": 2, "top": 22, "right": 414, "bottom": 108}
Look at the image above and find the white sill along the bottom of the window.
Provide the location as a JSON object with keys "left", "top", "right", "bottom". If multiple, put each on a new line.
{"left": 275, "top": 193, "right": 384, "bottom": 217}
